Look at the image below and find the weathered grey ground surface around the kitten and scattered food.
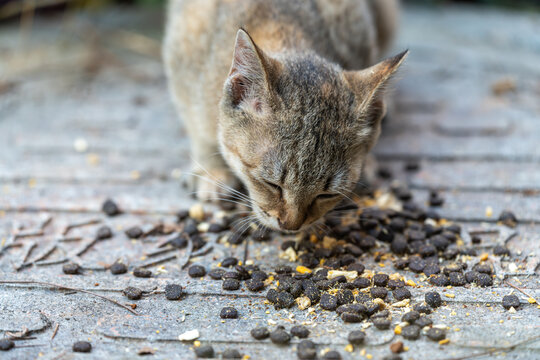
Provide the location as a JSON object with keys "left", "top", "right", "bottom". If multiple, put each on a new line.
{"left": 0, "top": 3, "right": 540, "bottom": 359}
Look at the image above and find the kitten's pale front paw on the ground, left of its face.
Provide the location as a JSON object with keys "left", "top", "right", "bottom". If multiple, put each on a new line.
{"left": 186, "top": 169, "right": 241, "bottom": 203}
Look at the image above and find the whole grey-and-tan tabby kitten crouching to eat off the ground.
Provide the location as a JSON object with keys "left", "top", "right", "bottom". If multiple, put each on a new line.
{"left": 164, "top": 0, "right": 407, "bottom": 231}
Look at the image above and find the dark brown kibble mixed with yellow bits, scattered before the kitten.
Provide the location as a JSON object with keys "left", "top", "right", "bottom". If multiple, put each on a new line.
{"left": 161, "top": 187, "right": 520, "bottom": 359}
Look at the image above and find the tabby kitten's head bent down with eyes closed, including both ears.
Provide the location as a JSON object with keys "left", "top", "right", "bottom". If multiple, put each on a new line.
{"left": 219, "top": 30, "right": 406, "bottom": 231}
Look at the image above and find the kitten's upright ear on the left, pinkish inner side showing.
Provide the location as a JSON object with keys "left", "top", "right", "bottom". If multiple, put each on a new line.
{"left": 225, "top": 29, "right": 273, "bottom": 113}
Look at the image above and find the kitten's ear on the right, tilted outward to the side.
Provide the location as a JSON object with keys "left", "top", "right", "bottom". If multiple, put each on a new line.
{"left": 344, "top": 50, "right": 409, "bottom": 125}
